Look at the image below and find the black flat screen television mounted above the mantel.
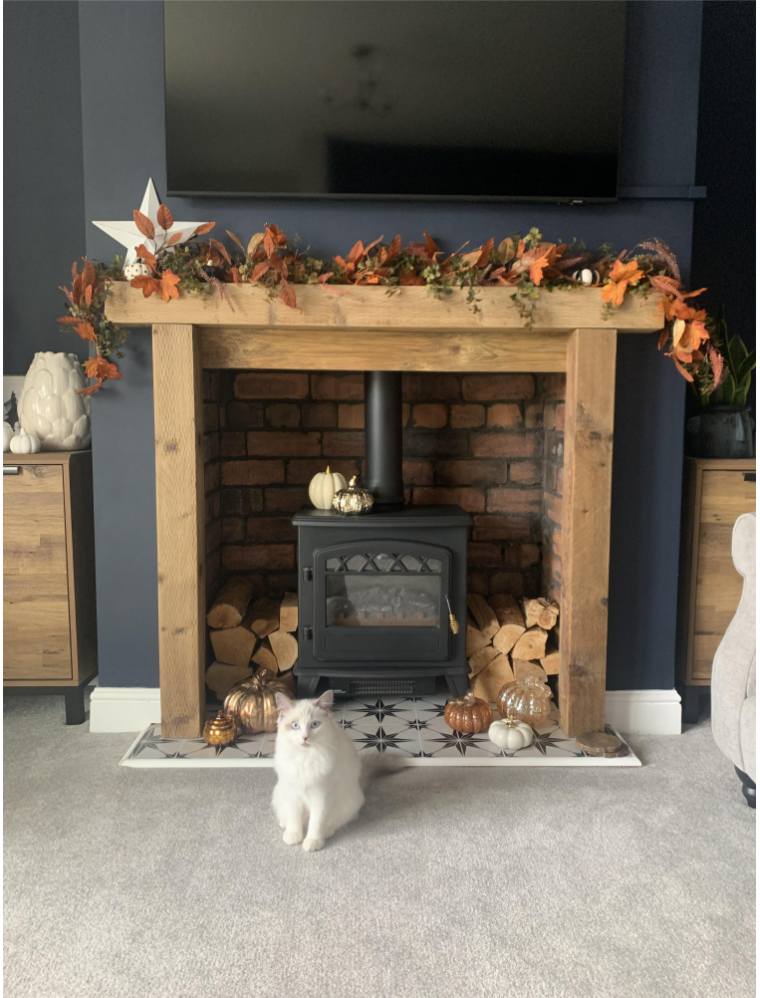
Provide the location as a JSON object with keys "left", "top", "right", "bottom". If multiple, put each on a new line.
{"left": 164, "top": 0, "right": 626, "bottom": 201}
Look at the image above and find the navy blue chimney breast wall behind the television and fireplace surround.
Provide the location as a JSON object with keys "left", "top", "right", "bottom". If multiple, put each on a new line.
{"left": 80, "top": 0, "right": 701, "bottom": 689}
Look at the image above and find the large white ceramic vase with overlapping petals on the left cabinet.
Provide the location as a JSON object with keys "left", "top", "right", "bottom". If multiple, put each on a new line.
{"left": 18, "top": 351, "right": 91, "bottom": 450}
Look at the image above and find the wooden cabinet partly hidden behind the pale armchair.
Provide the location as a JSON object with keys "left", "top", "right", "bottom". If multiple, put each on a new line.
{"left": 677, "top": 458, "right": 755, "bottom": 723}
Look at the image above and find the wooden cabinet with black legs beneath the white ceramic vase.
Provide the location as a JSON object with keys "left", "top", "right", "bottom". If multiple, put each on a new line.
{"left": 3, "top": 451, "right": 97, "bottom": 723}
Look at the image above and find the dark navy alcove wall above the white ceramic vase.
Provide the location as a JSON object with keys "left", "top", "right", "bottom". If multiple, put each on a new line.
{"left": 3, "top": 0, "right": 87, "bottom": 374}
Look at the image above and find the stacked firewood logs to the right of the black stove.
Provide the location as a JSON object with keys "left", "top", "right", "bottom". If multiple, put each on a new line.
{"left": 467, "top": 593, "right": 559, "bottom": 703}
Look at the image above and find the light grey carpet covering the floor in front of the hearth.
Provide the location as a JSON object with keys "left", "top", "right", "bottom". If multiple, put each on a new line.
{"left": 4, "top": 697, "right": 755, "bottom": 998}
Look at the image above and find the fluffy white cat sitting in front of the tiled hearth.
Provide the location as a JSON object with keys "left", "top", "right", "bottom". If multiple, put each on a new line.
{"left": 272, "top": 690, "right": 364, "bottom": 852}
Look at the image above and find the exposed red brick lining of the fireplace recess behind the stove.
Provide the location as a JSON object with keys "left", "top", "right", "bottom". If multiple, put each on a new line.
{"left": 203, "top": 371, "right": 565, "bottom": 598}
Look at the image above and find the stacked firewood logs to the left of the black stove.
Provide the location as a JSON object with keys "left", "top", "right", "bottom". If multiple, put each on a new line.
{"left": 206, "top": 576, "right": 298, "bottom": 700}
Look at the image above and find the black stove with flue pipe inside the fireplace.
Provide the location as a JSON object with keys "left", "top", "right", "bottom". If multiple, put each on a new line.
{"left": 293, "top": 372, "right": 472, "bottom": 697}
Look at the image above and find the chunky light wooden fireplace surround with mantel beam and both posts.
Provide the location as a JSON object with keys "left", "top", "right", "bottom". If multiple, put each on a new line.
{"left": 106, "top": 283, "right": 663, "bottom": 738}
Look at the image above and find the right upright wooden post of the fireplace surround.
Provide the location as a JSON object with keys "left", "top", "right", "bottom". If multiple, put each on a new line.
{"left": 559, "top": 329, "right": 617, "bottom": 735}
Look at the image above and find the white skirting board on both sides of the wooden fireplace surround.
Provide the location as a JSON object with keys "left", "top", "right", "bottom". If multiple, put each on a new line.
{"left": 90, "top": 686, "right": 681, "bottom": 735}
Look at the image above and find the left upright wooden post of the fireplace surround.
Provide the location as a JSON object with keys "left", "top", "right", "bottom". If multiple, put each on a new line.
{"left": 153, "top": 325, "right": 206, "bottom": 738}
